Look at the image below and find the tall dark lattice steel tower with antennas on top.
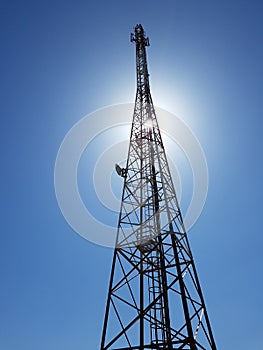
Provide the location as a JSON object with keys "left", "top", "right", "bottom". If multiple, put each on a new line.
{"left": 101, "top": 24, "right": 216, "bottom": 350}
